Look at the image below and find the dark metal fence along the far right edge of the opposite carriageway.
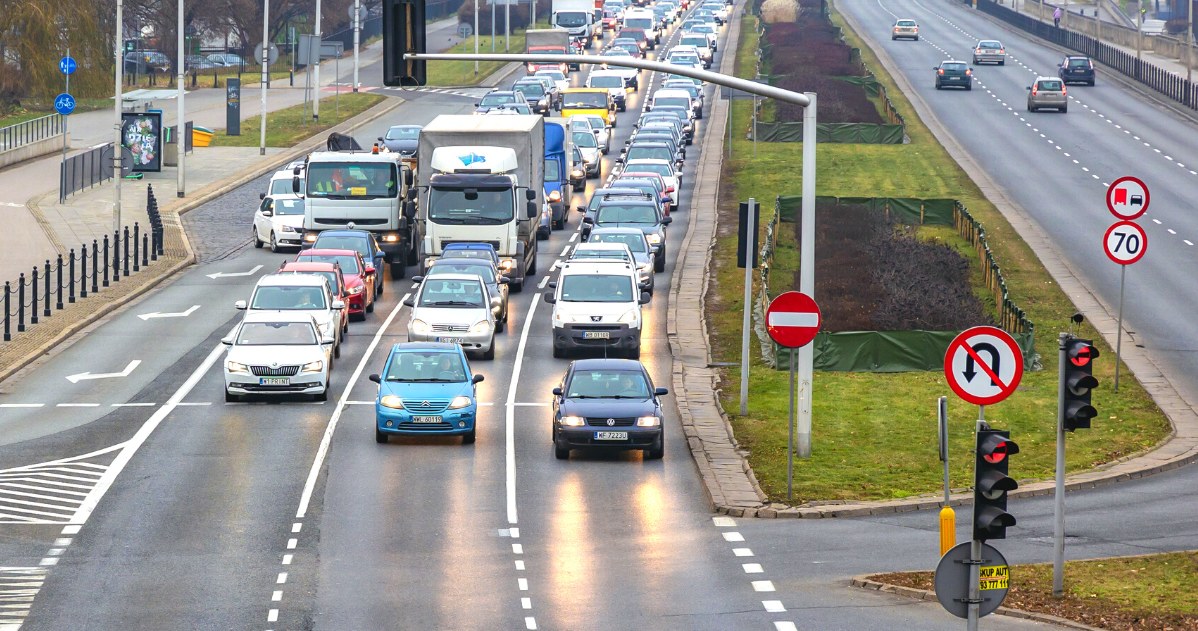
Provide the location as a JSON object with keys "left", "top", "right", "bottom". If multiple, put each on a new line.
{"left": 978, "top": 0, "right": 1198, "bottom": 109}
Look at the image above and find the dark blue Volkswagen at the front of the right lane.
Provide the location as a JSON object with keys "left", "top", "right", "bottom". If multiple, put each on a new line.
{"left": 553, "top": 359, "right": 670, "bottom": 460}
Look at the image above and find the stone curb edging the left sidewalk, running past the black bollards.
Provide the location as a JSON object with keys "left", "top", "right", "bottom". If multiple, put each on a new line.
{"left": 0, "top": 97, "right": 404, "bottom": 383}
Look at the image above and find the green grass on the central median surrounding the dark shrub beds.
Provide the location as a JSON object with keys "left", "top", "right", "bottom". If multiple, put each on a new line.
{"left": 707, "top": 12, "right": 1169, "bottom": 503}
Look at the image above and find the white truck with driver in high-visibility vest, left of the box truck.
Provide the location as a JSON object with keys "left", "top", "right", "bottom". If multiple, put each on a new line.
{"left": 292, "top": 151, "right": 415, "bottom": 278}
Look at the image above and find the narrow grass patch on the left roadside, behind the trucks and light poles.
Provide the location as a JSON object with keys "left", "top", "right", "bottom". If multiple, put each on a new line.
{"left": 212, "top": 92, "right": 386, "bottom": 147}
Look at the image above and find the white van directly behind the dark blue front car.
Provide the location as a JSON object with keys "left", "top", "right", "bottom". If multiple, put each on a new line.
{"left": 545, "top": 261, "right": 649, "bottom": 359}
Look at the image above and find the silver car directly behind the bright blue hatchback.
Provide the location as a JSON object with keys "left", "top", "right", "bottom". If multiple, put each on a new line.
{"left": 404, "top": 274, "right": 495, "bottom": 359}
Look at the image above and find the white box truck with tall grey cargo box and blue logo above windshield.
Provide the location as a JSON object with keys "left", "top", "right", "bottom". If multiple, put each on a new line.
{"left": 410, "top": 115, "right": 545, "bottom": 291}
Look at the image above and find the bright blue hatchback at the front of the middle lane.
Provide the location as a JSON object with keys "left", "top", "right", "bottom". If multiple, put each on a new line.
{"left": 370, "top": 341, "right": 483, "bottom": 444}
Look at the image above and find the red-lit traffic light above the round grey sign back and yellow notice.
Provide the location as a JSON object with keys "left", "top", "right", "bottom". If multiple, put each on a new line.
{"left": 973, "top": 430, "right": 1019, "bottom": 541}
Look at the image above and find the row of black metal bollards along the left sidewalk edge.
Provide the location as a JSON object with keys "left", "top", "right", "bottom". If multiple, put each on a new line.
{"left": 2, "top": 187, "right": 163, "bottom": 341}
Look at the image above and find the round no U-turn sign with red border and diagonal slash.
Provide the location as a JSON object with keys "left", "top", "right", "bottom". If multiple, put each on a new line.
{"left": 944, "top": 327, "right": 1023, "bottom": 406}
